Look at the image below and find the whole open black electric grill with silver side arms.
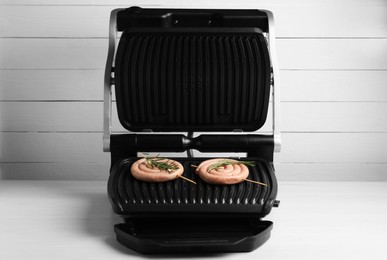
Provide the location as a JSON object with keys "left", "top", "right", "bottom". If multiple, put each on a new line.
{"left": 103, "top": 7, "right": 280, "bottom": 254}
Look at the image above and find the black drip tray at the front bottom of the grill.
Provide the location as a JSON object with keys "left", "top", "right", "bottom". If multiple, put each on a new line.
{"left": 114, "top": 217, "right": 273, "bottom": 254}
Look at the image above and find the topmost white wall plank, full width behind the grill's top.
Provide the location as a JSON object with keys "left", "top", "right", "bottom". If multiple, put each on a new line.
{"left": 0, "top": 0, "right": 387, "bottom": 38}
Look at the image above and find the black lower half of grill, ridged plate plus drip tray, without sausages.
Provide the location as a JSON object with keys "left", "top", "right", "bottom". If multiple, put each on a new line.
{"left": 108, "top": 158, "right": 277, "bottom": 254}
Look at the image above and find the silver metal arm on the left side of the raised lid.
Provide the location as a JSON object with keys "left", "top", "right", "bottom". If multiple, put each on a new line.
{"left": 103, "top": 8, "right": 124, "bottom": 152}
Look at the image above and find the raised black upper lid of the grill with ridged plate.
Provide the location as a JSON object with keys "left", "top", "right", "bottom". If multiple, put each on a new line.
{"left": 115, "top": 9, "right": 271, "bottom": 131}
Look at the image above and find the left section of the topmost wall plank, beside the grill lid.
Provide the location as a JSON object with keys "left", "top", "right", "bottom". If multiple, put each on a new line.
{"left": 0, "top": 5, "right": 110, "bottom": 38}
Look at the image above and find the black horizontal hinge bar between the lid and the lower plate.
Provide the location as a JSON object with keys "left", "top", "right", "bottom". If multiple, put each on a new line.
{"left": 110, "top": 134, "right": 274, "bottom": 161}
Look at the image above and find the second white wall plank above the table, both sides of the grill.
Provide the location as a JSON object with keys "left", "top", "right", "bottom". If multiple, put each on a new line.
{"left": 0, "top": 132, "right": 387, "bottom": 163}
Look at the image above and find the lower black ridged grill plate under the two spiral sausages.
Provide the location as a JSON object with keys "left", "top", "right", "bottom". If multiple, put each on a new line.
{"left": 109, "top": 158, "right": 276, "bottom": 215}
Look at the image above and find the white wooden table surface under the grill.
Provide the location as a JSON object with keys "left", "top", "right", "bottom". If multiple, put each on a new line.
{"left": 0, "top": 181, "right": 387, "bottom": 260}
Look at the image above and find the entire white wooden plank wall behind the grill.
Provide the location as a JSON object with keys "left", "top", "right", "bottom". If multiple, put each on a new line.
{"left": 0, "top": 0, "right": 387, "bottom": 181}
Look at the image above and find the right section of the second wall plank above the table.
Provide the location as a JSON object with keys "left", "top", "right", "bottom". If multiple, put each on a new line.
{"left": 275, "top": 133, "right": 387, "bottom": 163}
